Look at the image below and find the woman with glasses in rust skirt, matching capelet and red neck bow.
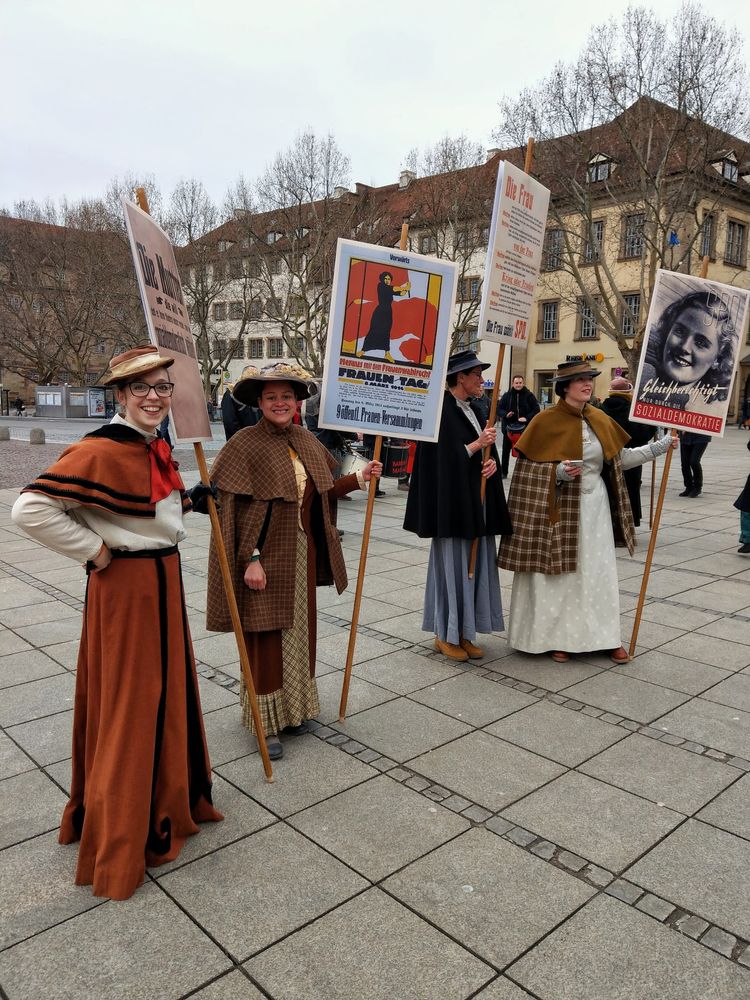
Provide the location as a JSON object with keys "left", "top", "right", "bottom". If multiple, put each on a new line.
{"left": 13, "top": 346, "right": 222, "bottom": 899}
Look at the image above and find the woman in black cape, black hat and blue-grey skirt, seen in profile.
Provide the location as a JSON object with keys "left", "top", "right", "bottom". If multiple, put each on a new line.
{"left": 404, "top": 351, "right": 511, "bottom": 660}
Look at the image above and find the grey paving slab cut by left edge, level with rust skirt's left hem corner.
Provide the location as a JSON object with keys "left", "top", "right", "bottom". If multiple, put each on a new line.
{"left": 0, "top": 771, "right": 67, "bottom": 850}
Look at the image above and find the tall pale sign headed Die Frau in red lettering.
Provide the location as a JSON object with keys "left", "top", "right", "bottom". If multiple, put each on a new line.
{"left": 479, "top": 160, "right": 549, "bottom": 347}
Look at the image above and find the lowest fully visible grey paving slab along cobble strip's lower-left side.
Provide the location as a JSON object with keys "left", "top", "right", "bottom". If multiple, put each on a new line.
{"left": 384, "top": 829, "right": 595, "bottom": 968}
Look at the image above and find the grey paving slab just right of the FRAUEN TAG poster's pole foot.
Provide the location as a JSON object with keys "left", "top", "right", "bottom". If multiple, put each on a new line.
{"left": 334, "top": 698, "right": 470, "bottom": 763}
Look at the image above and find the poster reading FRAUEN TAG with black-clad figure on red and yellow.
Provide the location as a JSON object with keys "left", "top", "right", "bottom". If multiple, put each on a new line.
{"left": 319, "top": 240, "right": 458, "bottom": 441}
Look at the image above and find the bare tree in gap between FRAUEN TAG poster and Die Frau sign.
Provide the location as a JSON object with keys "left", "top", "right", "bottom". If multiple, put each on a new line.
{"left": 405, "top": 135, "right": 490, "bottom": 350}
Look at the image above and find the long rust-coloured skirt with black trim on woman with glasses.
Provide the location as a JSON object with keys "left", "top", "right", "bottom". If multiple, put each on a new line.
{"left": 59, "top": 546, "right": 223, "bottom": 899}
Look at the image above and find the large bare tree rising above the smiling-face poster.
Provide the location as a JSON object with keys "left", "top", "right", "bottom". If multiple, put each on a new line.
{"left": 496, "top": 3, "right": 748, "bottom": 364}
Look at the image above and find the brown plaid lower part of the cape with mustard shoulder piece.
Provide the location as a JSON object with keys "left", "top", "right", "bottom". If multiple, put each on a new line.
{"left": 497, "top": 454, "right": 635, "bottom": 576}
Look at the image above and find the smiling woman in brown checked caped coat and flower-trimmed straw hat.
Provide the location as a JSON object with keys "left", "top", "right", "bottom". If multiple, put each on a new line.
{"left": 207, "top": 363, "right": 382, "bottom": 759}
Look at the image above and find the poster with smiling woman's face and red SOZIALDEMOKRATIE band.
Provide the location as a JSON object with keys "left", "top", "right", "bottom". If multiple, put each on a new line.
{"left": 630, "top": 271, "right": 750, "bottom": 437}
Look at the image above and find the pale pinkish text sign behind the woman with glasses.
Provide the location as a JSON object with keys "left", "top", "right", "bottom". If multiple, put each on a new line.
{"left": 123, "top": 199, "right": 211, "bottom": 441}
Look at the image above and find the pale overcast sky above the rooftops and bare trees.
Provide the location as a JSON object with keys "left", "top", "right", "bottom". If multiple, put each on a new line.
{"left": 0, "top": 0, "right": 748, "bottom": 208}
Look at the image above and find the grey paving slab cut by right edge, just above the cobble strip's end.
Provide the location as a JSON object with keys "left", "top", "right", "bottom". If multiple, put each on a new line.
{"left": 627, "top": 820, "right": 750, "bottom": 940}
